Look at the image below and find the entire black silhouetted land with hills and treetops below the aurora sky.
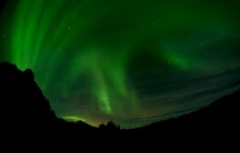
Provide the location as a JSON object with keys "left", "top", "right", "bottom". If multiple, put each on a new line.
{"left": 0, "top": 62, "right": 240, "bottom": 148}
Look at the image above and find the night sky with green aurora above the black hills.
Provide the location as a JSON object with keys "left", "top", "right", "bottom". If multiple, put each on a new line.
{"left": 0, "top": 0, "right": 240, "bottom": 128}
